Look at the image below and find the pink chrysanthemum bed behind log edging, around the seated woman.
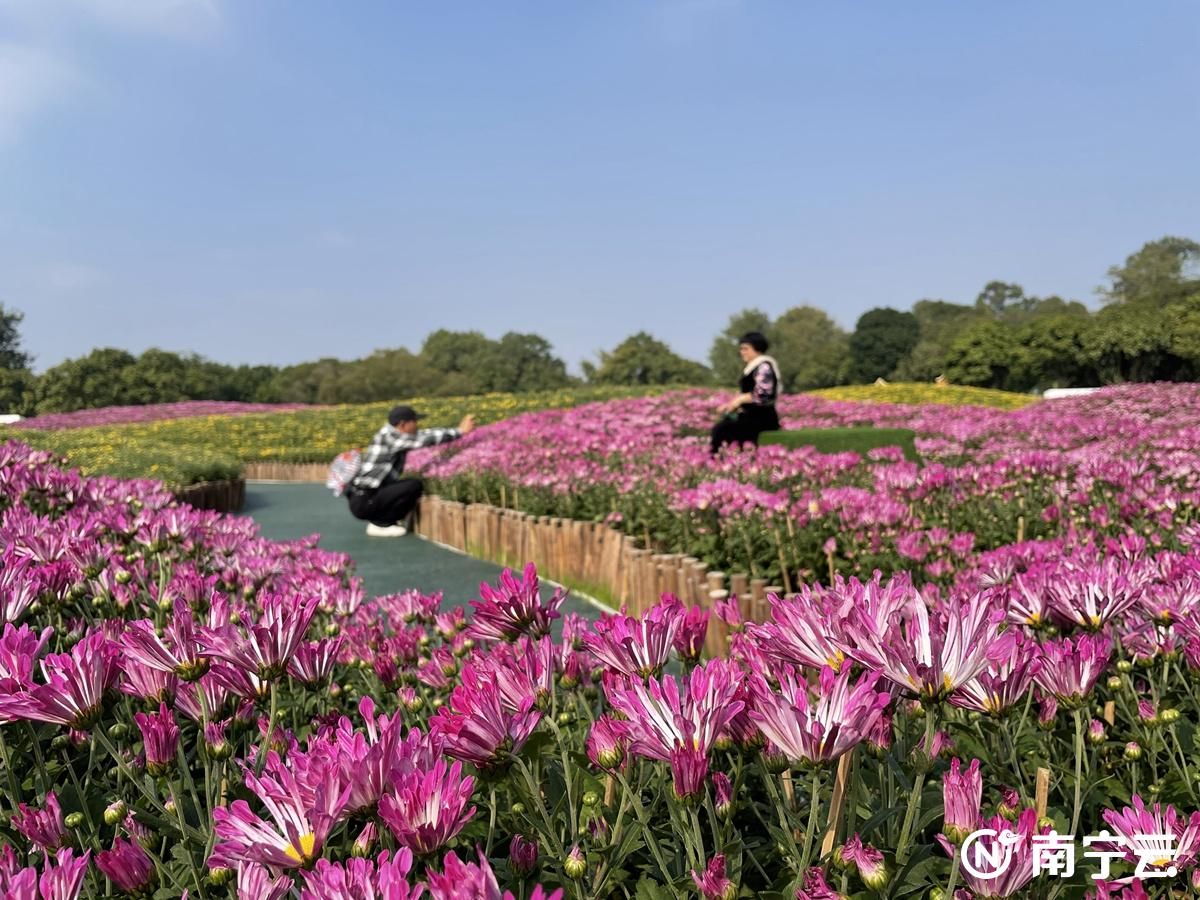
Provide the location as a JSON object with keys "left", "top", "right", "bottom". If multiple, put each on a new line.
{"left": 410, "top": 384, "right": 1200, "bottom": 592}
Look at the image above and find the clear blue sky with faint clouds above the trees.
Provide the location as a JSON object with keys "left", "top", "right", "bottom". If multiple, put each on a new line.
{"left": 0, "top": 0, "right": 1200, "bottom": 370}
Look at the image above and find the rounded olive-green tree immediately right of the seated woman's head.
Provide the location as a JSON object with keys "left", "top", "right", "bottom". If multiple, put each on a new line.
{"left": 768, "top": 306, "right": 850, "bottom": 391}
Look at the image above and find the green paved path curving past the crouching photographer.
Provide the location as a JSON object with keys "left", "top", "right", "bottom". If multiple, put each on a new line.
{"left": 242, "top": 482, "right": 598, "bottom": 618}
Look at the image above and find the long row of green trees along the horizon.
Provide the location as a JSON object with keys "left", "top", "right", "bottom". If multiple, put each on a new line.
{"left": 0, "top": 238, "right": 1200, "bottom": 415}
